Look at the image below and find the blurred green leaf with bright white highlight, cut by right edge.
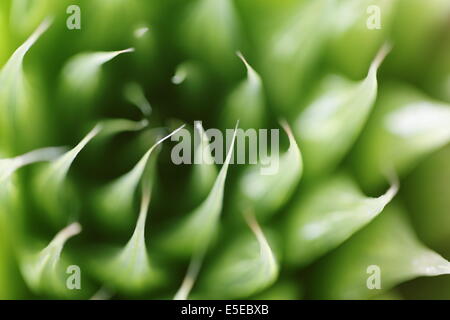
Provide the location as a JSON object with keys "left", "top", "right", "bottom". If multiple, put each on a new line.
{"left": 352, "top": 85, "right": 450, "bottom": 188}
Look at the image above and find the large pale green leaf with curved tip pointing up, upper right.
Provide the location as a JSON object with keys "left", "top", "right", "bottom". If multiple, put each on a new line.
{"left": 294, "top": 45, "right": 390, "bottom": 177}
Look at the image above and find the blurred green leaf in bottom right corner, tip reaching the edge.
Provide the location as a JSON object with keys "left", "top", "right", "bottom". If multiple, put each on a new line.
{"left": 311, "top": 205, "right": 450, "bottom": 299}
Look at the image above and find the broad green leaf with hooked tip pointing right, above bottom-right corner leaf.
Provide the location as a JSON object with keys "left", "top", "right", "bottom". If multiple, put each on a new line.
{"left": 284, "top": 174, "right": 398, "bottom": 266}
